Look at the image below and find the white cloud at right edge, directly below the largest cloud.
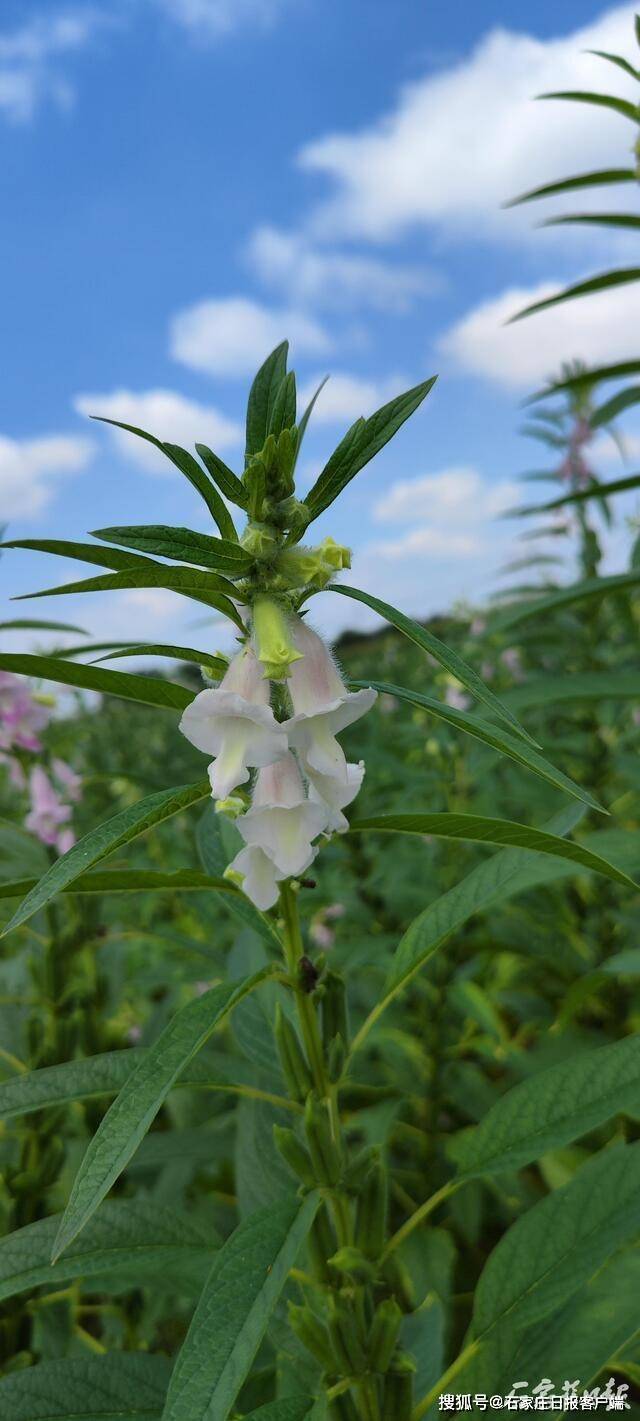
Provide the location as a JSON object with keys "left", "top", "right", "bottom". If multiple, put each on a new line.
{"left": 439, "top": 283, "right": 640, "bottom": 388}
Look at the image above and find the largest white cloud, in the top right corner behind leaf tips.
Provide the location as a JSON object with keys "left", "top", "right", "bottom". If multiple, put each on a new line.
{"left": 299, "top": 4, "right": 637, "bottom": 240}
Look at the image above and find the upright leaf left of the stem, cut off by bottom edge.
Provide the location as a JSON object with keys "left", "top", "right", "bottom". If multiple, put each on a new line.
{"left": 162, "top": 1192, "right": 320, "bottom": 1421}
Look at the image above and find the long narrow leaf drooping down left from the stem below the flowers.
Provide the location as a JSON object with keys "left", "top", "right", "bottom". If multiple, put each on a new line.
{"left": 53, "top": 968, "right": 273, "bottom": 1262}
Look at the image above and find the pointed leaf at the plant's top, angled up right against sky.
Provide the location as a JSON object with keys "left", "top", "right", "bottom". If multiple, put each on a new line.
{"left": 304, "top": 375, "right": 437, "bottom": 519}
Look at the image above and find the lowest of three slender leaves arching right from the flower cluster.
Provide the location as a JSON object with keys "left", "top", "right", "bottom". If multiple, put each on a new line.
{"left": 350, "top": 814, "right": 637, "bottom": 888}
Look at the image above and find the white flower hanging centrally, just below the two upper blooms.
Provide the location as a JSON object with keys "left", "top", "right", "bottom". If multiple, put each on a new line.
{"left": 236, "top": 755, "right": 329, "bottom": 878}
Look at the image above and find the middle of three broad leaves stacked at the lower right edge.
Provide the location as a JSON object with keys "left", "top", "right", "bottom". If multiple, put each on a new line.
{"left": 472, "top": 1142, "right": 640, "bottom": 1339}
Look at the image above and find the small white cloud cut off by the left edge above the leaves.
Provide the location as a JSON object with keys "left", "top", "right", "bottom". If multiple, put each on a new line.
{"left": 0, "top": 435, "right": 94, "bottom": 522}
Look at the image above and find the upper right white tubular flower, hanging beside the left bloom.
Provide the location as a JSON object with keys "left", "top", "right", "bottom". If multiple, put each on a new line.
{"left": 283, "top": 621, "right": 377, "bottom": 778}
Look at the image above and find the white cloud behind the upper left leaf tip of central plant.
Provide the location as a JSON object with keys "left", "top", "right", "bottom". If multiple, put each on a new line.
{"left": 74, "top": 389, "right": 243, "bottom": 475}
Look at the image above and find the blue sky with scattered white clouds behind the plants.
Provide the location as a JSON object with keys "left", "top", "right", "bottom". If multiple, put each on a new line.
{"left": 0, "top": 0, "right": 640, "bottom": 653}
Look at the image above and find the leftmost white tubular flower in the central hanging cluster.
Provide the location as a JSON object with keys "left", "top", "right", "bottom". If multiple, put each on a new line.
{"left": 181, "top": 647, "right": 287, "bottom": 799}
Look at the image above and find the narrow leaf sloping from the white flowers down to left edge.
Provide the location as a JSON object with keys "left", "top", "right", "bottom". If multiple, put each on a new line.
{"left": 3, "top": 778, "right": 210, "bottom": 935}
